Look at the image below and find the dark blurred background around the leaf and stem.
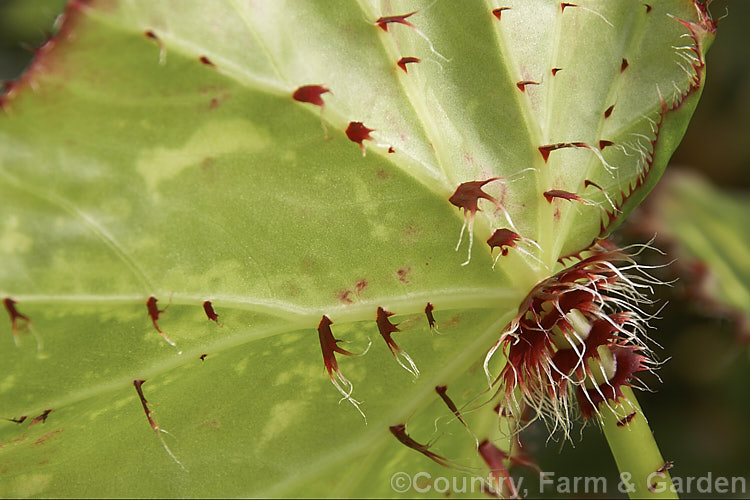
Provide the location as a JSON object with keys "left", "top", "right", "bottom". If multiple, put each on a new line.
{"left": 0, "top": 0, "right": 750, "bottom": 498}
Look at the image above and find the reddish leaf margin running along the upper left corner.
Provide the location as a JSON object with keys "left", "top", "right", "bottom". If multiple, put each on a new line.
{"left": 0, "top": 0, "right": 93, "bottom": 112}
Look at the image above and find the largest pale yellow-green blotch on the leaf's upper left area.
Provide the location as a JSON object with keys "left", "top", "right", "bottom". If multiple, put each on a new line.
{"left": 136, "top": 120, "right": 271, "bottom": 193}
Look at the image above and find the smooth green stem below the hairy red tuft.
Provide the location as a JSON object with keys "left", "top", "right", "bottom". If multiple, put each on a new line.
{"left": 600, "top": 387, "right": 678, "bottom": 498}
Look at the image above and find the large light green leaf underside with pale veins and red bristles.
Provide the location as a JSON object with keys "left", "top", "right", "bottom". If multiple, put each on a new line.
{"left": 0, "top": 1, "right": 704, "bottom": 496}
